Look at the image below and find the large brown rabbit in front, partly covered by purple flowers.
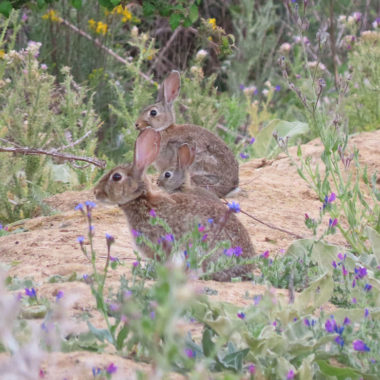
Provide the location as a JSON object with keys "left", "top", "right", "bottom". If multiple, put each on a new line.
{"left": 94, "top": 128, "right": 255, "bottom": 281}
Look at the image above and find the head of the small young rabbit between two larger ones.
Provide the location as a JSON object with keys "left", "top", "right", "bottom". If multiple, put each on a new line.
{"left": 157, "top": 143, "right": 196, "bottom": 193}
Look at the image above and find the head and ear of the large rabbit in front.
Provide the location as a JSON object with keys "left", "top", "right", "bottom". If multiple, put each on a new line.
{"left": 94, "top": 128, "right": 161, "bottom": 205}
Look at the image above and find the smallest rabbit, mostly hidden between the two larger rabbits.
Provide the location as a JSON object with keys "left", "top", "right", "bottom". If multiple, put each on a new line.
{"left": 157, "top": 144, "right": 219, "bottom": 201}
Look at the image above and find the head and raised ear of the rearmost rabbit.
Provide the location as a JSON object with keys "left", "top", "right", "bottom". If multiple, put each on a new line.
{"left": 135, "top": 71, "right": 181, "bottom": 131}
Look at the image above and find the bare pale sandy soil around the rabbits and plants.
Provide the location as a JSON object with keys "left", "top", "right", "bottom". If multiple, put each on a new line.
{"left": 0, "top": 130, "right": 380, "bottom": 380}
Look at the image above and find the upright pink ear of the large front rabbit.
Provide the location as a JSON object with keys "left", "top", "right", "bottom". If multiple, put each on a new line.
{"left": 133, "top": 128, "right": 161, "bottom": 177}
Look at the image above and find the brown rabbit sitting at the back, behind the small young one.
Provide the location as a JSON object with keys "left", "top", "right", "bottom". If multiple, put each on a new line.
{"left": 135, "top": 71, "right": 239, "bottom": 197}
